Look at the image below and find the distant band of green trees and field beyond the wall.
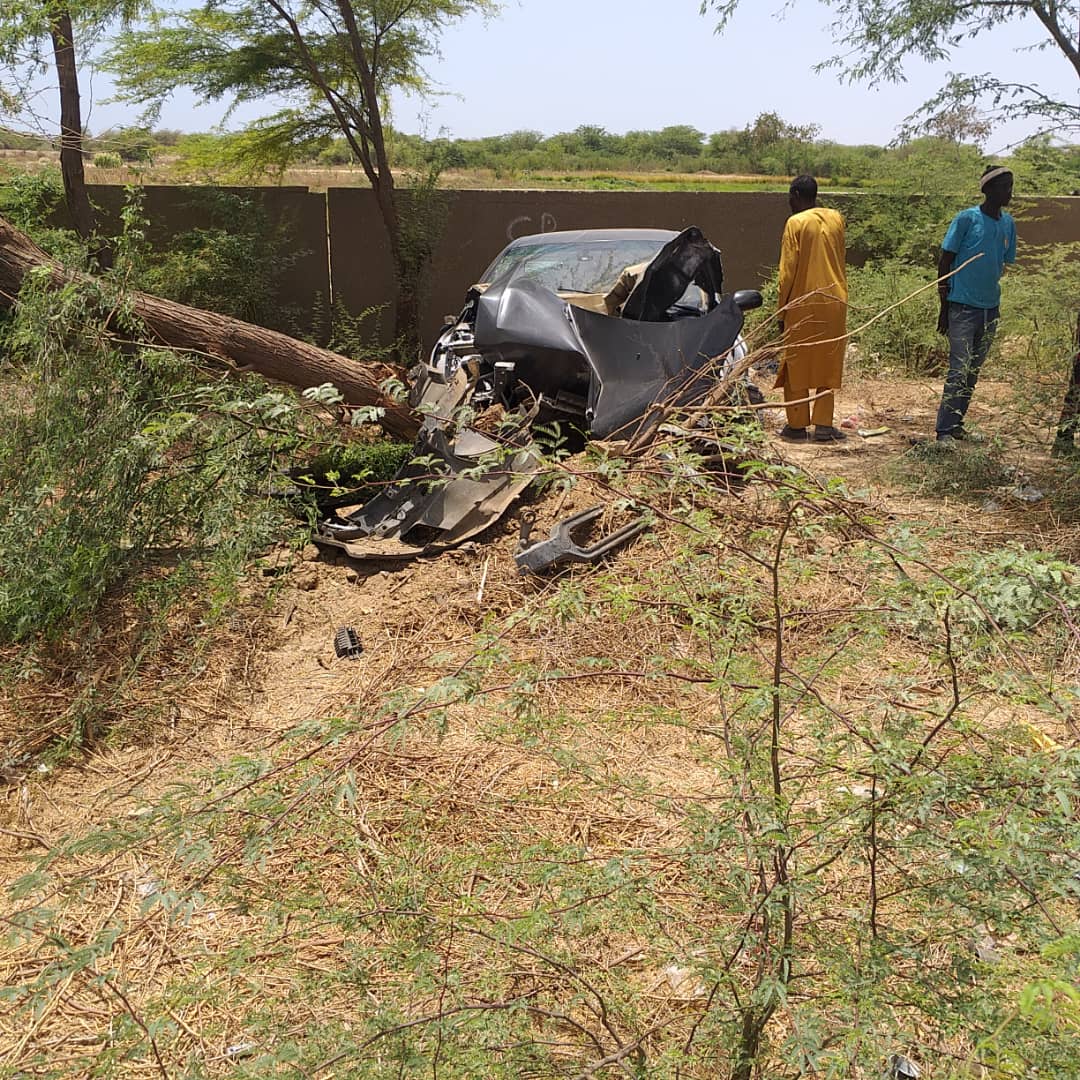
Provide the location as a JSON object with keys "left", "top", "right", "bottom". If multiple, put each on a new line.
{"left": 6, "top": 112, "right": 1080, "bottom": 195}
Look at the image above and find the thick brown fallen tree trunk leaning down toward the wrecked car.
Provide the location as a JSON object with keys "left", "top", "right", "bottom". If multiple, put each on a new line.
{"left": 0, "top": 217, "right": 419, "bottom": 438}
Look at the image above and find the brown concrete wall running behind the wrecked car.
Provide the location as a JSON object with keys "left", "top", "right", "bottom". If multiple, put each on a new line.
{"left": 71, "top": 187, "right": 1080, "bottom": 341}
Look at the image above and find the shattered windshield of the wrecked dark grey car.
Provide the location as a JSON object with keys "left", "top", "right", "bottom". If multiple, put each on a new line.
{"left": 481, "top": 237, "right": 664, "bottom": 293}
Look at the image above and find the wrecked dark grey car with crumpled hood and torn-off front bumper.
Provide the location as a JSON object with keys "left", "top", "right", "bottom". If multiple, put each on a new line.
{"left": 315, "top": 226, "right": 761, "bottom": 558}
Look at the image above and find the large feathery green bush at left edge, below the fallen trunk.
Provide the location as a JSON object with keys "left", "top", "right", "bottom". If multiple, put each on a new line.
{"left": 0, "top": 276, "right": 302, "bottom": 642}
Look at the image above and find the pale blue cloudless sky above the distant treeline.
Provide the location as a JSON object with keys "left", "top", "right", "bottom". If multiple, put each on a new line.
{"left": 19, "top": 0, "right": 1078, "bottom": 153}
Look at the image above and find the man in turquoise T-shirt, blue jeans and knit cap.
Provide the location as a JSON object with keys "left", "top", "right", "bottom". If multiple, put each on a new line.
{"left": 936, "top": 165, "right": 1016, "bottom": 443}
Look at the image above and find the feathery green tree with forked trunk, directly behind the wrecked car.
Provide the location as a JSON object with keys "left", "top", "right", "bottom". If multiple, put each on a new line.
{"left": 106, "top": 0, "right": 496, "bottom": 354}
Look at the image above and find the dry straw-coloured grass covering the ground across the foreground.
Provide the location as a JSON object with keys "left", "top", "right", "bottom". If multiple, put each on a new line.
{"left": 0, "top": 383, "right": 1080, "bottom": 1078}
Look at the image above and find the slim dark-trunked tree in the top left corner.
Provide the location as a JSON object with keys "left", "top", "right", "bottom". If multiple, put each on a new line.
{"left": 0, "top": 0, "right": 149, "bottom": 264}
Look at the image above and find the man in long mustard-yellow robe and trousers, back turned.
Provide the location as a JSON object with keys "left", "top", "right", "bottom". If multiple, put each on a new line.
{"left": 775, "top": 176, "right": 848, "bottom": 443}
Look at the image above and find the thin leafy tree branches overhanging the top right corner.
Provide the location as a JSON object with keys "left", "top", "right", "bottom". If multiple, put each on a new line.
{"left": 701, "top": 0, "right": 1080, "bottom": 134}
